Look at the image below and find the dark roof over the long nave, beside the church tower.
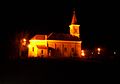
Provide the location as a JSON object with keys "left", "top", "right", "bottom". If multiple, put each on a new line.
{"left": 48, "top": 33, "right": 80, "bottom": 41}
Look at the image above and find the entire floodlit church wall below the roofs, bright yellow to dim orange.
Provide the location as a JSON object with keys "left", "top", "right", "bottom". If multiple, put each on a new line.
{"left": 28, "top": 40, "right": 81, "bottom": 57}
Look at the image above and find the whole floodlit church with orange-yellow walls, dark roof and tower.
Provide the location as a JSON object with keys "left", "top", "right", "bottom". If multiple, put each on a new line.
{"left": 28, "top": 11, "right": 82, "bottom": 58}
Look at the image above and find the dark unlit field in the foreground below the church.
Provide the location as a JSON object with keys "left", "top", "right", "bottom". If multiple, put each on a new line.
{"left": 0, "top": 58, "right": 119, "bottom": 84}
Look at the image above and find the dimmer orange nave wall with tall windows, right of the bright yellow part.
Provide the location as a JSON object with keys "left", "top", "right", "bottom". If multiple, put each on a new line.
{"left": 48, "top": 40, "right": 81, "bottom": 57}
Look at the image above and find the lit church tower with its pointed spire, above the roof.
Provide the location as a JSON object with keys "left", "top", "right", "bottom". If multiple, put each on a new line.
{"left": 69, "top": 10, "right": 80, "bottom": 38}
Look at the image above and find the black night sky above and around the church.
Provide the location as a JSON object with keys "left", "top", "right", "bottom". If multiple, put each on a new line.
{"left": 0, "top": 0, "right": 120, "bottom": 57}
